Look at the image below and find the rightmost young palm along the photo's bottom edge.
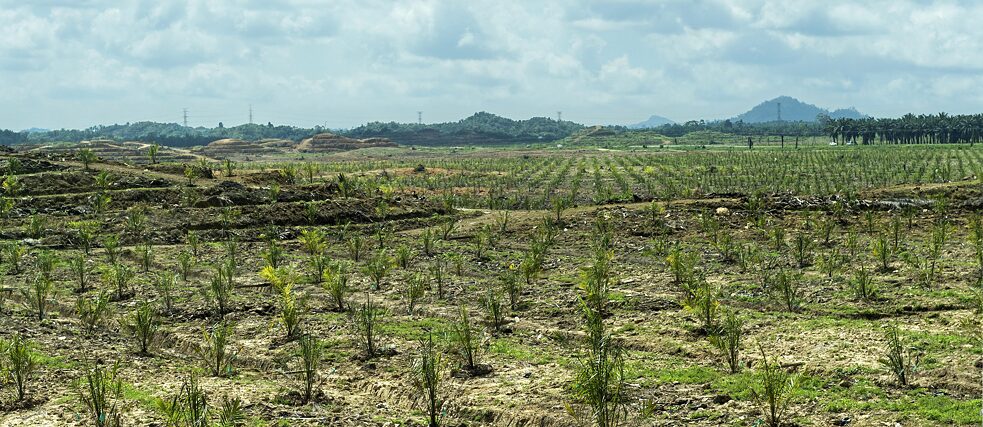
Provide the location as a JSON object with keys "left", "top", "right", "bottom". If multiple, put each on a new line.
{"left": 751, "top": 348, "right": 798, "bottom": 427}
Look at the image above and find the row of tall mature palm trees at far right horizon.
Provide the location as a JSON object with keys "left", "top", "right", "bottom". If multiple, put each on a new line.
{"left": 820, "top": 113, "right": 983, "bottom": 145}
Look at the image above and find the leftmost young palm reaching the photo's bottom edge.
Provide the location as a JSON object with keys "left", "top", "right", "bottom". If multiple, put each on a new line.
{"left": 75, "top": 363, "right": 123, "bottom": 427}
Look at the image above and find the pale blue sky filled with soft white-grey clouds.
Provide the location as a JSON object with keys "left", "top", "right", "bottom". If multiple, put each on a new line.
{"left": 0, "top": 0, "right": 983, "bottom": 130}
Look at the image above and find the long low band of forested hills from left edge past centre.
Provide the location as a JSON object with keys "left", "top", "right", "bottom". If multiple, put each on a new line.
{"left": 0, "top": 112, "right": 583, "bottom": 147}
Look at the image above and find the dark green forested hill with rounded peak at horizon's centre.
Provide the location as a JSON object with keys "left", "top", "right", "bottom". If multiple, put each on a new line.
{"left": 345, "top": 112, "right": 584, "bottom": 145}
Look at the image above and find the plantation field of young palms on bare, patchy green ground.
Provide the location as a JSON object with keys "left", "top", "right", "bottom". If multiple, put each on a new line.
{"left": 0, "top": 145, "right": 983, "bottom": 427}
